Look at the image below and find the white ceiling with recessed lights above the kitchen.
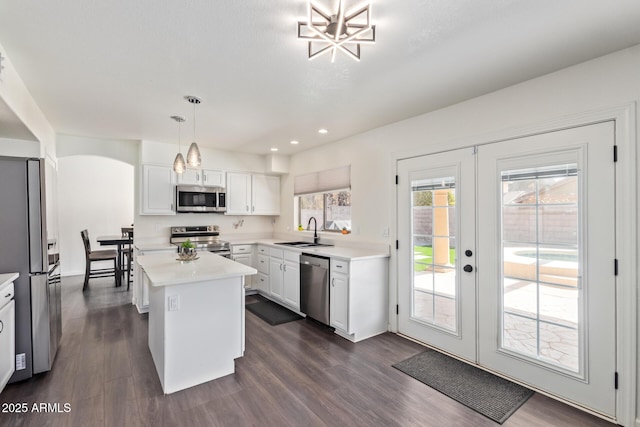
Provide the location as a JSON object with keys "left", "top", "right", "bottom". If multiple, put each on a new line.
{"left": 0, "top": 0, "right": 640, "bottom": 154}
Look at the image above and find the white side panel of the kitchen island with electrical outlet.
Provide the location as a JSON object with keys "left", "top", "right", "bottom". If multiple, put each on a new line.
{"left": 161, "top": 277, "right": 244, "bottom": 393}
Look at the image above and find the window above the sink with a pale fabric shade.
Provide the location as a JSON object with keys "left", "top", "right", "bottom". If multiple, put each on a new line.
{"left": 294, "top": 166, "right": 351, "bottom": 232}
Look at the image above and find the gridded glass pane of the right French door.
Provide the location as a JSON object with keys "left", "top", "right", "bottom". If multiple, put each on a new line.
{"left": 501, "top": 163, "right": 583, "bottom": 372}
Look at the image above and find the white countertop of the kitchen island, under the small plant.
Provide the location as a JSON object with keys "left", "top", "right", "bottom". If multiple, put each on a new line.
{"left": 137, "top": 251, "right": 258, "bottom": 286}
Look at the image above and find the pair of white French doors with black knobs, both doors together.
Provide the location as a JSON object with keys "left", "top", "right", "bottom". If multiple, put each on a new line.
{"left": 398, "top": 122, "right": 616, "bottom": 418}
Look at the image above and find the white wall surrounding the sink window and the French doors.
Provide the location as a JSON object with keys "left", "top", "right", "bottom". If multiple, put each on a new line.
{"left": 275, "top": 45, "right": 640, "bottom": 426}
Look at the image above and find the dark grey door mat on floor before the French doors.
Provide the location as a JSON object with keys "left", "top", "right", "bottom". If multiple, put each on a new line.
{"left": 392, "top": 350, "right": 534, "bottom": 424}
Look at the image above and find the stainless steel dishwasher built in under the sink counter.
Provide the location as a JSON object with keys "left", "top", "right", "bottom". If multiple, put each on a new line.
{"left": 300, "top": 254, "right": 329, "bottom": 325}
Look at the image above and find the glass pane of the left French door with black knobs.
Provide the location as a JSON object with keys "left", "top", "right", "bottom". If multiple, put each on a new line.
{"left": 411, "top": 177, "right": 458, "bottom": 332}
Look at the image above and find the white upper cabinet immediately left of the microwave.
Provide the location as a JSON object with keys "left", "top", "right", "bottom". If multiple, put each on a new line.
{"left": 140, "top": 164, "right": 176, "bottom": 215}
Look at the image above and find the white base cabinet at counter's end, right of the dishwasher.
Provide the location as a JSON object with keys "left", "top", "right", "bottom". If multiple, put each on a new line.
{"left": 329, "top": 258, "right": 389, "bottom": 342}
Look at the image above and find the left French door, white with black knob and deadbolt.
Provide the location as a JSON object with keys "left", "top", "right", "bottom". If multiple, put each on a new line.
{"left": 398, "top": 148, "right": 477, "bottom": 361}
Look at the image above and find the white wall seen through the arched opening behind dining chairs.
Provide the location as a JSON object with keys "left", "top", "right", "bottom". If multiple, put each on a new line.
{"left": 58, "top": 156, "right": 134, "bottom": 275}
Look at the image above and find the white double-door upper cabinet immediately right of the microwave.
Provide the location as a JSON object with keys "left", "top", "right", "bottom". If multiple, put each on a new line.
{"left": 226, "top": 172, "right": 280, "bottom": 215}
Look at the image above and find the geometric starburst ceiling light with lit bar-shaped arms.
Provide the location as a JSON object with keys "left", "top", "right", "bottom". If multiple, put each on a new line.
{"left": 298, "top": 0, "right": 376, "bottom": 62}
